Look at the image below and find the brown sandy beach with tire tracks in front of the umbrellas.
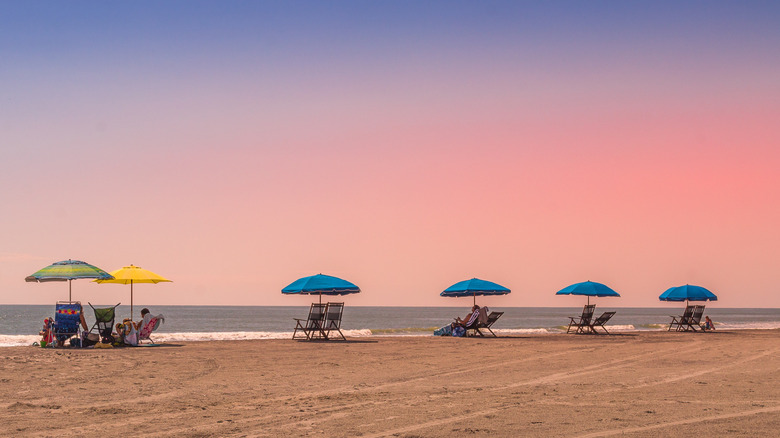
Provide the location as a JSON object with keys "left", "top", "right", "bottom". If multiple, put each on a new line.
{"left": 0, "top": 330, "right": 780, "bottom": 437}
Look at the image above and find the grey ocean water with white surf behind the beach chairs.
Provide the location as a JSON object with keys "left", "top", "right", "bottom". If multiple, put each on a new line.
{"left": 0, "top": 303, "right": 780, "bottom": 347}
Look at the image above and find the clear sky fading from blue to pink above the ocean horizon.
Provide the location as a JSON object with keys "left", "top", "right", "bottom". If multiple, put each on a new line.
{"left": 0, "top": 0, "right": 780, "bottom": 308}
